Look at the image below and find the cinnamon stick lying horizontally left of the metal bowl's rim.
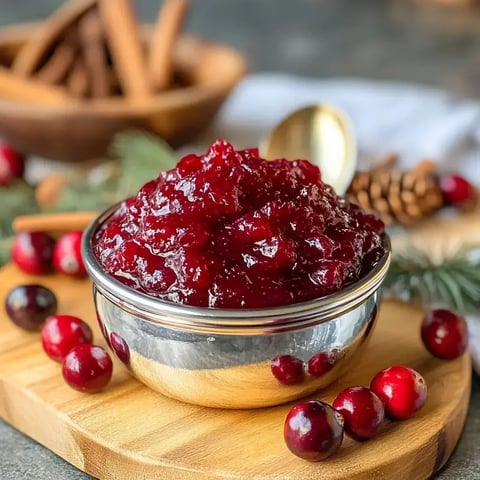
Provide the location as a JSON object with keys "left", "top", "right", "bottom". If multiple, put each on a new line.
{"left": 12, "top": 212, "right": 98, "bottom": 232}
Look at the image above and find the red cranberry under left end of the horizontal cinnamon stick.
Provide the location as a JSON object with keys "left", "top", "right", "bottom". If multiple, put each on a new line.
{"left": 12, "top": 232, "right": 55, "bottom": 275}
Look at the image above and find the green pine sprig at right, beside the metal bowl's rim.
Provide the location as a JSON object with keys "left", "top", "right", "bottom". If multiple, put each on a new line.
{"left": 384, "top": 245, "right": 480, "bottom": 315}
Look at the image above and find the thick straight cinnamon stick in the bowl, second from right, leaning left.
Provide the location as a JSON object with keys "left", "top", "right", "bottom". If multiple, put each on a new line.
{"left": 98, "top": 0, "right": 150, "bottom": 101}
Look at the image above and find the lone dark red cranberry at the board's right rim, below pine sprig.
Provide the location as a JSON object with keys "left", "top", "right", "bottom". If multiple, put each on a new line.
{"left": 422, "top": 309, "right": 468, "bottom": 360}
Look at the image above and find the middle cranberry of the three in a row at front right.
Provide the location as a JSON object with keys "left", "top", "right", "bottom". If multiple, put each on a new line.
{"left": 332, "top": 387, "right": 385, "bottom": 440}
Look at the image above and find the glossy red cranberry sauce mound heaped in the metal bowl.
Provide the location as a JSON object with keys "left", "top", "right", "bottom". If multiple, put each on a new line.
{"left": 95, "top": 140, "right": 384, "bottom": 308}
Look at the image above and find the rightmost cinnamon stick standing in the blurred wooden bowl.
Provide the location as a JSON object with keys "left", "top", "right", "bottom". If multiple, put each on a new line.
{"left": 148, "top": 0, "right": 188, "bottom": 91}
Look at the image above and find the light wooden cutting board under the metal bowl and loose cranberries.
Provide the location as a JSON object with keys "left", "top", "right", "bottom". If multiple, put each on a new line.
{"left": 0, "top": 266, "right": 471, "bottom": 480}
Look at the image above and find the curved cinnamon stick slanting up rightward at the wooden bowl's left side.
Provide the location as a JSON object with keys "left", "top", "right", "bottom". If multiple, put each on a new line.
{"left": 12, "top": 0, "right": 97, "bottom": 77}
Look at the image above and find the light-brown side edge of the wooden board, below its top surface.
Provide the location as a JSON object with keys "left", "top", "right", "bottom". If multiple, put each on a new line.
{"left": 0, "top": 344, "right": 471, "bottom": 480}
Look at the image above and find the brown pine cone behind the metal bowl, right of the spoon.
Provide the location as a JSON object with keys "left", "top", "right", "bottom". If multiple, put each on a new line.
{"left": 347, "top": 161, "right": 443, "bottom": 225}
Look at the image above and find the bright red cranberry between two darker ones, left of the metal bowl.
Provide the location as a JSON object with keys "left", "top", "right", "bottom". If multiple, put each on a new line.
{"left": 42, "top": 315, "right": 93, "bottom": 362}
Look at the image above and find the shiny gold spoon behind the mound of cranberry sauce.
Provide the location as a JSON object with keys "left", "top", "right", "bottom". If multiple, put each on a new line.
{"left": 260, "top": 103, "right": 357, "bottom": 195}
